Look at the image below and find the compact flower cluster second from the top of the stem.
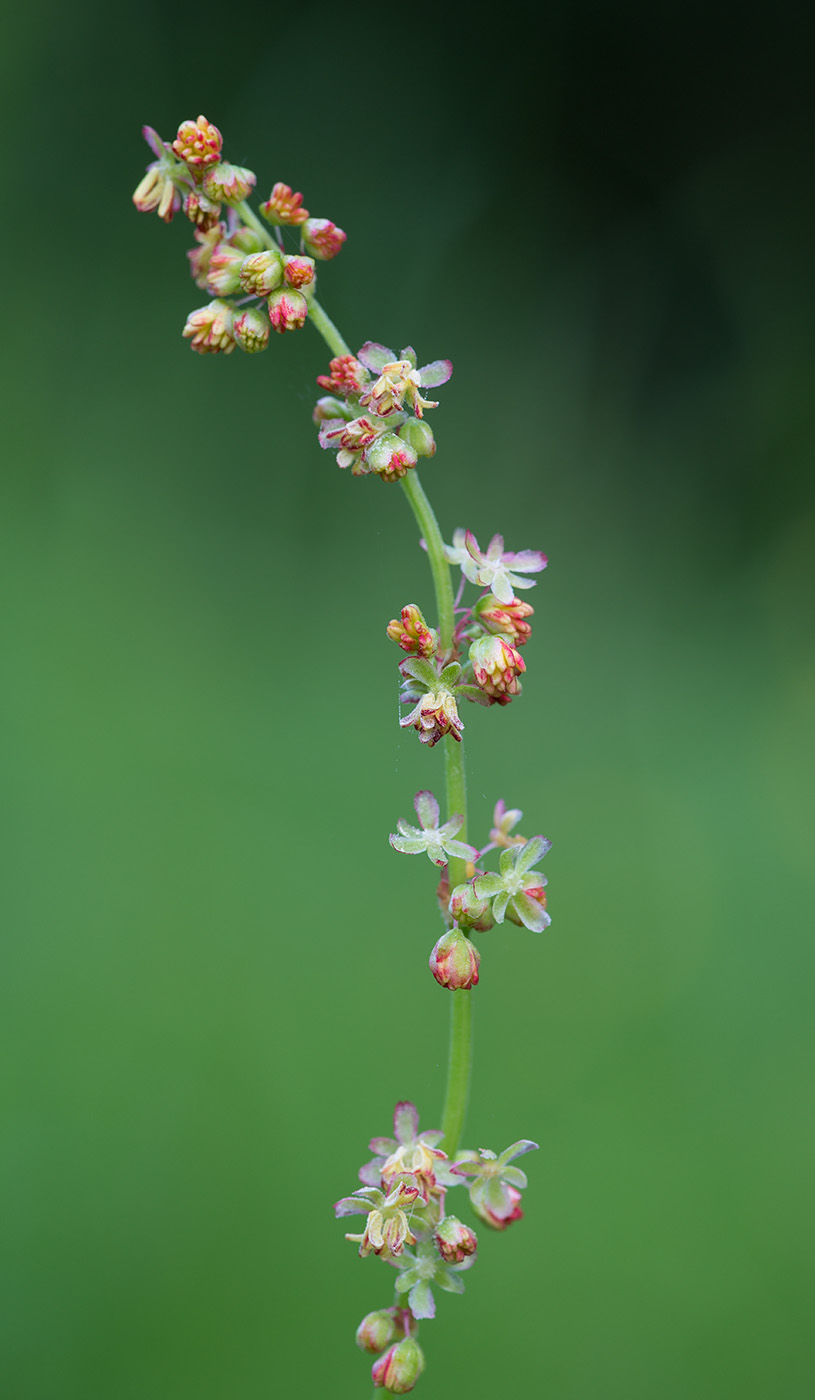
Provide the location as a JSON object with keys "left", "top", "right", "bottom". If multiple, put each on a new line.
{"left": 314, "top": 340, "right": 452, "bottom": 482}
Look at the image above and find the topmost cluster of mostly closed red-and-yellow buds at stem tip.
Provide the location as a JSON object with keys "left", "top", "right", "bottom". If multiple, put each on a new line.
{"left": 133, "top": 116, "right": 346, "bottom": 354}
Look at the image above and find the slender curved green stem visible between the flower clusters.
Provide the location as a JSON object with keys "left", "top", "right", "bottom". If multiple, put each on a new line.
{"left": 302, "top": 287, "right": 472, "bottom": 1156}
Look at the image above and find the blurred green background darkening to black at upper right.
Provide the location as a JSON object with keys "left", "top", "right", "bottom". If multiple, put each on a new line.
{"left": 0, "top": 0, "right": 815, "bottom": 1400}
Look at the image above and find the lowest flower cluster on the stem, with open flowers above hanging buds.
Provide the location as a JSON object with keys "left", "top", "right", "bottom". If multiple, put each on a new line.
{"left": 335, "top": 1102, "right": 536, "bottom": 1394}
